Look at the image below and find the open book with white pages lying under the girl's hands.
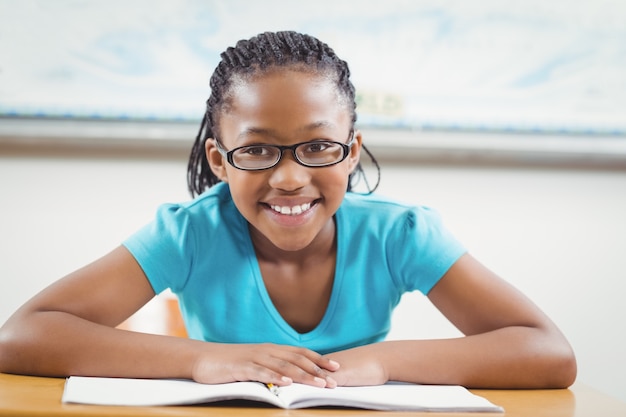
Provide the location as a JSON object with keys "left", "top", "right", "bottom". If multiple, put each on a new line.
{"left": 62, "top": 376, "right": 504, "bottom": 412}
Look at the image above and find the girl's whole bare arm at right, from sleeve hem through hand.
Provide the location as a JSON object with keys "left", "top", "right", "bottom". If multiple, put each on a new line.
{"left": 329, "top": 255, "right": 576, "bottom": 388}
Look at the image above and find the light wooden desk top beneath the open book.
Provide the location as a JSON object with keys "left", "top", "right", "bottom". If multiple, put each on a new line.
{"left": 0, "top": 374, "right": 626, "bottom": 417}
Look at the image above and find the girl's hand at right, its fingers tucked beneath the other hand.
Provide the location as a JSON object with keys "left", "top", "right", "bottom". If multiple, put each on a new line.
{"left": 327, "top": 343, "right": 389, "bottom": 386}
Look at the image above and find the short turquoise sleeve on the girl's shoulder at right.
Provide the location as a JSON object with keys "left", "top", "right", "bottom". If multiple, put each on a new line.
{"left": 387, "top": 206, "right": 466, "bottom": 294}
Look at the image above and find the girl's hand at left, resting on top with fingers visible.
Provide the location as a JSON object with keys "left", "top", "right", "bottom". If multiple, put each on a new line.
{"left": 192, "top": 343, "right": 339, "bottom": 388}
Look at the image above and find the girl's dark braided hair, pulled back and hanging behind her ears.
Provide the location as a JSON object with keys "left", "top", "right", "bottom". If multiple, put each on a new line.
{"left": 187, "top": 31, "right": 380, "bottom": 197}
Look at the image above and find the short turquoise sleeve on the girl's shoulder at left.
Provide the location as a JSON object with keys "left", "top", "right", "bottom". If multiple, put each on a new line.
{"left": 123, "top": 204, "right": 195, "bottom": 294}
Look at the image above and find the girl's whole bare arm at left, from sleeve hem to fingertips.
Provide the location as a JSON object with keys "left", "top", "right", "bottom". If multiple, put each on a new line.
{"left": 0, "top": 247, "right": 337, "bottom": 386}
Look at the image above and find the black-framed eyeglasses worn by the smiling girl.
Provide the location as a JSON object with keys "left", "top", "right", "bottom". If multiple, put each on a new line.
{"left": 215, "top": 130, "right": 354, "bottom": 171}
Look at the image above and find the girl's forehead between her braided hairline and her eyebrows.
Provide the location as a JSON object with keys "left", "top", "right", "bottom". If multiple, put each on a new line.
{"left": 219, "top": 69, "right": 351, "bottom": 135}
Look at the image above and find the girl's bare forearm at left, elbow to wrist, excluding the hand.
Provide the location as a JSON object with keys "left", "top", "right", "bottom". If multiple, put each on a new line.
{"left": 0, "top": 311, "right": 204, "bottom": 378}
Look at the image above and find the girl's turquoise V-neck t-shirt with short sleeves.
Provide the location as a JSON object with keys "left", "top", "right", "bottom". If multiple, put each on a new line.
{"left": 124, "top": 183, "right": 465, "bottom": 354}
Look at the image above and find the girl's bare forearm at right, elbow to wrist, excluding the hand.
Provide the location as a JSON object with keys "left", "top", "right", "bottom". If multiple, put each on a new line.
{"left": 372, "top": 326, "right": 576, "bottom": 388}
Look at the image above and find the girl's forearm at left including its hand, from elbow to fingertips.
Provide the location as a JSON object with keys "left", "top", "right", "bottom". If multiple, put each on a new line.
{"left": 0, "top": 311, "right": 338, "bottom": 387}
